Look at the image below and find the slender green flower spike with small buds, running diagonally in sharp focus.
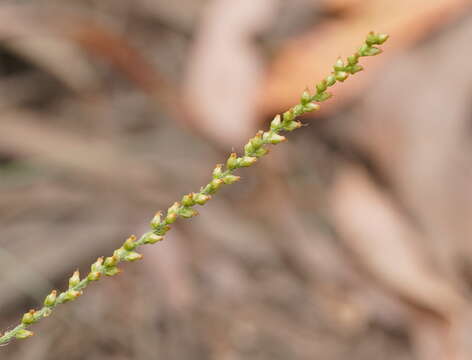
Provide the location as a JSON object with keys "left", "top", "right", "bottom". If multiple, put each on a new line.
{"left": 0, "top": 32, "right": 388, "bottom": 344}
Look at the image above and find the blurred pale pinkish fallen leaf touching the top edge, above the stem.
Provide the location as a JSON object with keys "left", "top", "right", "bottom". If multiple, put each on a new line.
{"left": 184, "top": 0, "right": 276, "bottom": 145}
